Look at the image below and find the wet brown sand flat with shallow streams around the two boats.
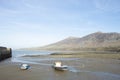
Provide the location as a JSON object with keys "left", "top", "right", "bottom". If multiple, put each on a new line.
{"left": 0, "top": 57, "right": 120, "bottom": 80}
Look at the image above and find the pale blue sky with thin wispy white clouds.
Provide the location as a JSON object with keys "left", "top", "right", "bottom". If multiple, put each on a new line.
{"left": 0, "top": 0, "right": 120, "bottom": 49}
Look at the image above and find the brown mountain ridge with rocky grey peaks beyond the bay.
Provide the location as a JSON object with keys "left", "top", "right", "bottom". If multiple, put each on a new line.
{"left": 28, "top": 32, "right": 120, "bottom": 51}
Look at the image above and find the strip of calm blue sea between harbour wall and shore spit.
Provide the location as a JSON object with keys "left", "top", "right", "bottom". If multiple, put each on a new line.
{"left": 12, "top": 50, "right": 52, "bottom": 57}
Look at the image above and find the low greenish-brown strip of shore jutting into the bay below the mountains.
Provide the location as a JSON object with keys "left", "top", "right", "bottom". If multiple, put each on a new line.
{"left": 22, "top": 52, "right": 120, "bottom": 60}
